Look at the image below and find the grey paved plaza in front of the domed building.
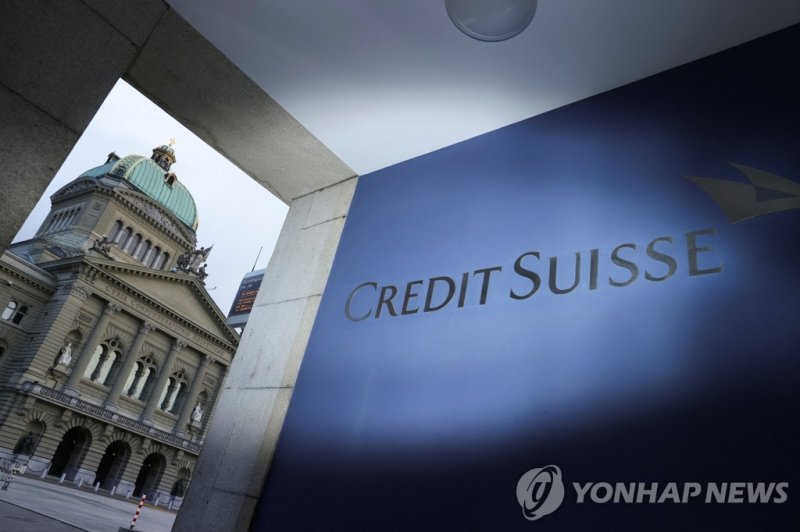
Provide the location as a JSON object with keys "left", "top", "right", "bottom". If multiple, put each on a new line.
{"left": 0, "top": 477, "right": 176, "bottom": 532}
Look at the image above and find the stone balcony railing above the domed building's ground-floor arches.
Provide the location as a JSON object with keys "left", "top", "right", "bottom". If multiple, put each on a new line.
{"left": 22, "top": 382, "right": 200, "bottom": 454}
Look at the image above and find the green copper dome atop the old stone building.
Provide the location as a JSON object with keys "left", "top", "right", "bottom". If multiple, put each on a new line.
{"left": 101, "top": 155, "right": 198, "bottom": 229}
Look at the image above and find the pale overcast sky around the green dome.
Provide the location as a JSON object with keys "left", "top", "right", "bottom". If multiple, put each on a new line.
{"left": 15, "top": 81, "right": 288, "bottom": 315}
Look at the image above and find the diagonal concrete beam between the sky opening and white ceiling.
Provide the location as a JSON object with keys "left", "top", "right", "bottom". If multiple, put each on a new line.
{"left": 125, "top": 10, "right": 355, "bottom": 204}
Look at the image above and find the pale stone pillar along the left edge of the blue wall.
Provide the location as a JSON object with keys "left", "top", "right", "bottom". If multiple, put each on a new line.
{"left": 173, "top": 179, "right": 356, "bottom": 531}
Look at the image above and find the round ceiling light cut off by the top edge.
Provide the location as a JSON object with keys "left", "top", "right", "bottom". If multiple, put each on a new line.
{"left": 444, "top": 0, "right": 536, "bottom": 41}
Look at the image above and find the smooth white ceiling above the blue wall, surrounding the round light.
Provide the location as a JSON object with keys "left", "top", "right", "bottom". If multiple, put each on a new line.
{"left": 168, "top": 0, "right": 800, "bottom": 174}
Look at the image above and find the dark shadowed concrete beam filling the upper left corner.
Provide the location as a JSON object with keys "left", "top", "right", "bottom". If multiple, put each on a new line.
{"left": 0, "top": 0, "right": 155, "bottom": 253}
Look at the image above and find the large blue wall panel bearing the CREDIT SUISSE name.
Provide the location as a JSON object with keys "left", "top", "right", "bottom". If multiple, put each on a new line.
{"left": 254, "top": 27, "right": 800, "bottom": 530}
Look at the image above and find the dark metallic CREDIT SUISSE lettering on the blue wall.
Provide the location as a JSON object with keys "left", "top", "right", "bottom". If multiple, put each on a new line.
{"left": 344, "top": 228, "right": 722, "bottom": 321}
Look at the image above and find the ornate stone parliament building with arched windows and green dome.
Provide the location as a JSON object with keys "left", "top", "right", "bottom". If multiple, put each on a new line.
{"left": 0, "top": 145, "right": 239, "bottom": 500}
